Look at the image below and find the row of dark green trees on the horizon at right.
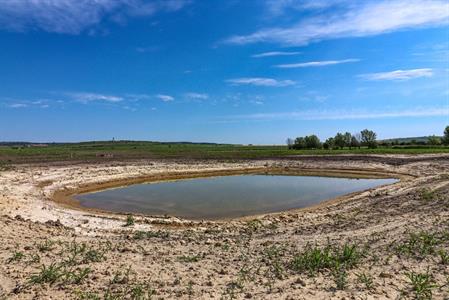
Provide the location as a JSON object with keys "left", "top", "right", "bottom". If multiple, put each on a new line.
{"left": 286, "top": 126, "right": 449, "bottom": 150}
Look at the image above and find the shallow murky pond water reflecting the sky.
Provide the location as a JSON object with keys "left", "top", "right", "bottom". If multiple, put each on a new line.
{"left": 75, "top": 175, "right": 397, "bottom": 220}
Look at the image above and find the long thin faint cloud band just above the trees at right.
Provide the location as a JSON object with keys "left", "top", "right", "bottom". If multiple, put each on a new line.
{"left": 221, "top": 107, "right": 449, "bottom": 121}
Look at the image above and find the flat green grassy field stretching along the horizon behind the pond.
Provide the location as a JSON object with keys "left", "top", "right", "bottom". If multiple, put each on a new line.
{"left": 0, "top": 141, "right": 449, "bottom": 164}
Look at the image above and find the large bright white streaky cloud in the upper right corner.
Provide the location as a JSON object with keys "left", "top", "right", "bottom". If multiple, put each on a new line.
{"left": 225, "top": 0, "right": 449, "bottom": 46}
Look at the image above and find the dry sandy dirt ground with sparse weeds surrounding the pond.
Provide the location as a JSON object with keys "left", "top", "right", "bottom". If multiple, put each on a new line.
{"left": 0, "top": 155, "right": 449, "bottom": 299}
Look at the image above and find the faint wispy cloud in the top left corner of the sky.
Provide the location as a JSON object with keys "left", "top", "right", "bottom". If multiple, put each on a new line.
{"left": 0, "top": 0, "right": 190, "bottom": 34}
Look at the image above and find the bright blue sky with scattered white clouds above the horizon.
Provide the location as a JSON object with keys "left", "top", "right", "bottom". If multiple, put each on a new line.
{"left": 0, "top": 0, "right": 449, "bottom": 144}
